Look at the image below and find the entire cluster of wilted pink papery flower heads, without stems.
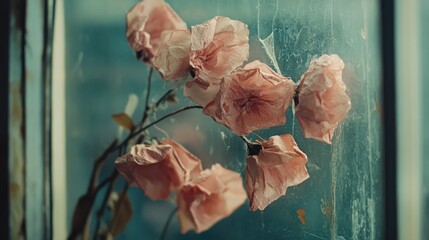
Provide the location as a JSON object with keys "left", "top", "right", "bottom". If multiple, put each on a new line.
{"left": 116, "top": 0, "right": 351, "bottom": 232}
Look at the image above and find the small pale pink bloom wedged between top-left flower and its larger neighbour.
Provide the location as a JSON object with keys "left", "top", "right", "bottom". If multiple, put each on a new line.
{"left": 153, "top": 30, "right": 191, "bottom": 79}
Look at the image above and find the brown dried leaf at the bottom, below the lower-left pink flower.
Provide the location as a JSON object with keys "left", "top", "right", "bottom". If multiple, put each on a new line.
{"left": 110, "top": 194, "right": 133, "bottom": 236}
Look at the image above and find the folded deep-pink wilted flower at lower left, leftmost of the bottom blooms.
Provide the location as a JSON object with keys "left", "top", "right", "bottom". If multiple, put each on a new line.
{"left": 115, "top": 140, "right": 202, "bottom": 200}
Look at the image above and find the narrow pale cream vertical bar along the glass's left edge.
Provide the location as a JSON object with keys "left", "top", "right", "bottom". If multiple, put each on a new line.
{"left": 51, "top": 0, "right": 67, "bottom": 239}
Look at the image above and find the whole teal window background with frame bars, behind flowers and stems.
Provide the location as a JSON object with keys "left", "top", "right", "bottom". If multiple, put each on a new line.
{"left": 0, "top": 0, "right": 429, "bottom": 240}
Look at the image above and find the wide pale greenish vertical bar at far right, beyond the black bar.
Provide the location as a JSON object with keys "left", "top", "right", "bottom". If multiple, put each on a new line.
{"left": 395, "top": 0, "right": 424, "bottom": 240}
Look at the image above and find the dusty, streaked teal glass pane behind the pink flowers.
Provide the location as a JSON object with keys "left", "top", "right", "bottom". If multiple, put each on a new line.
{"left": 65, "top": 0, "right": 382, "bottom": 239}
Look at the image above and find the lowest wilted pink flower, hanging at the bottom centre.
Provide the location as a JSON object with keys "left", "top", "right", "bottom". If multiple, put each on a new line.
{"left": 177, "top": 164, "right": 246, "bottom": 233}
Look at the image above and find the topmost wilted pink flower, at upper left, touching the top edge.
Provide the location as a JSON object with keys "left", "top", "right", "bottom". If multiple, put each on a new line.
{"left": 127, "top": 0, "right": 186, "bottom": 63}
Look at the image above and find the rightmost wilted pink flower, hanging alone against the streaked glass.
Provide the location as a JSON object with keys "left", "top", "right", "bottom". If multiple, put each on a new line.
{"left": 296, "top": 54, "right": 351, "bottom": 144}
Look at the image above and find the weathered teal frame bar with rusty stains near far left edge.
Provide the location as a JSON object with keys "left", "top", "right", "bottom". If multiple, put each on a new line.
{"left": 7, "top": 0, "right": 27, "bottom": 239}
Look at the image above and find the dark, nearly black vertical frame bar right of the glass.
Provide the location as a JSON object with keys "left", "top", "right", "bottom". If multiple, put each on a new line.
{"left": 380, "top": 0, "right": 398, "bottom": 240}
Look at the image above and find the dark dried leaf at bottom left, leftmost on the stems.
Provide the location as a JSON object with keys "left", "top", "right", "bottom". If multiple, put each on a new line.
{"left": 72, "top": 194, "right": 94, "bottom": 236}
